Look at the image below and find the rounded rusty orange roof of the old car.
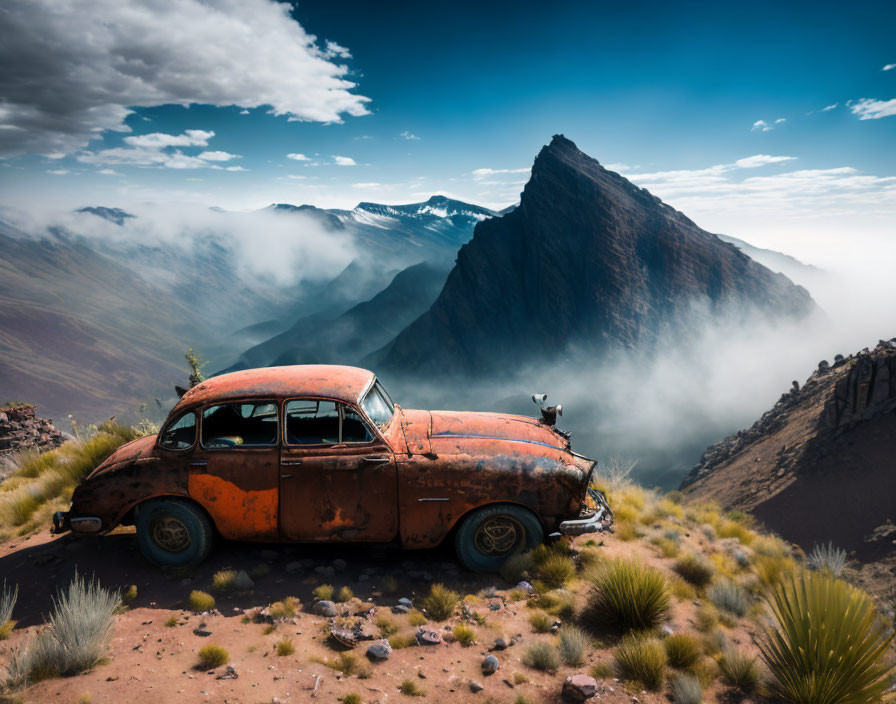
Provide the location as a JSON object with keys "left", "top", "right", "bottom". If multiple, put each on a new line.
{"left": 172, "top": 364, "right": 375, "bottom": 413}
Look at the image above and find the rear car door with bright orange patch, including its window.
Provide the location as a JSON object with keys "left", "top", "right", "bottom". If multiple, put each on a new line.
{"left": 188, "top": 400, "right": 280, "bottom": 540}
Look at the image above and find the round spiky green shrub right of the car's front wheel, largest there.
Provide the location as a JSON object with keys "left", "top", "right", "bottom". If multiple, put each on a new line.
{"left": 583, "top": 560, "right": 670, "bottom": 632}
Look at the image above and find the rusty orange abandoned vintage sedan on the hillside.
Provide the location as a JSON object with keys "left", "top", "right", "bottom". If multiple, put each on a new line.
{"left": 53, "top": 365, "right": 612, "bottom": 571}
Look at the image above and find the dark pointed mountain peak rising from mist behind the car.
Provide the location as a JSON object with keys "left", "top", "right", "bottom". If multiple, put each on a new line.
{"left": 384, "top": 136, "right": 815, "bottom": 374}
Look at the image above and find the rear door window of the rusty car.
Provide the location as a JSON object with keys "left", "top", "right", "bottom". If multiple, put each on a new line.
{"left": 202, "top": 401, "right": 278, "bottom": 450}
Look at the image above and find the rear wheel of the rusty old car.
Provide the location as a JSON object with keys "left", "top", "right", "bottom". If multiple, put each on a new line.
{"left": 134, "top": 499, "right": 214, "bottom": 567}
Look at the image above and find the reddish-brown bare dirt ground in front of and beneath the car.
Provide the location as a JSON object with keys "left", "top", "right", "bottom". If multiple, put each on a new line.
{"left": 0, "top": 531, "right": 759, "bottom": 704}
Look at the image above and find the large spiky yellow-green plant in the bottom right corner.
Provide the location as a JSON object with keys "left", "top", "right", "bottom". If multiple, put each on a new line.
{"left": 759, "top": 572, "right": 894, "bottom": 704}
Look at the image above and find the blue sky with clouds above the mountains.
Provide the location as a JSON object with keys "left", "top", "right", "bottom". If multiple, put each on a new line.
{"left": 0, "top": 0, "right": 896, "bottom": 258}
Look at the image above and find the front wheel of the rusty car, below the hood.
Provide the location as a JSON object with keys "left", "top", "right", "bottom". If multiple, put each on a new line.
{"left": 454, "top": 504, "right": 544, "bottom": 572}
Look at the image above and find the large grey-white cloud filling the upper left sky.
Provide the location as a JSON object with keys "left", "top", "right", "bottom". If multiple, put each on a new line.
{"left": 0, "top": 0, "right": 368, "bottom": 155}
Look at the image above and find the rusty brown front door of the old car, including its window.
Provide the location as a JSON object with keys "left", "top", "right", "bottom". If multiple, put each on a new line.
{"left": 280, "top": 398, "right": 398, "bottom": 542}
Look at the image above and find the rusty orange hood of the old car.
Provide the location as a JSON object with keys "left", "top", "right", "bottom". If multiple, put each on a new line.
{"left": 402, "top": 409, "right": 569, "bottom": 454}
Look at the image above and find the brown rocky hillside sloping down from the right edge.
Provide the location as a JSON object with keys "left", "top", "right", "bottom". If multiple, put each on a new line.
{"left": 682, "top": 338, "right": 896, "bottom": 559}
